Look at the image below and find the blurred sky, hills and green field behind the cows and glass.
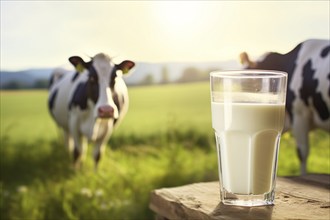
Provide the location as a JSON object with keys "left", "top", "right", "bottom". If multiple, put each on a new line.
{"left": 0, "top": 1, "right": 330, "bottom": 219}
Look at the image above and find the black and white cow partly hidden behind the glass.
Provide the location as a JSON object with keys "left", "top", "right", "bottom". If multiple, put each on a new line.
{"left": 240, "top": 40, "right": 330, "bottom": 174}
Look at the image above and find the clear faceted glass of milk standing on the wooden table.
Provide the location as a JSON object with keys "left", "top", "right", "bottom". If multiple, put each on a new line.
{"left": 210, "top": 70, "right": 287, "bottom": 206}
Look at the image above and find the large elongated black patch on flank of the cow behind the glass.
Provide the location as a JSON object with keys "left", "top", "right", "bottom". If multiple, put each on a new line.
{"left": 299, "top": 60, "right": 330, "bottom": 120}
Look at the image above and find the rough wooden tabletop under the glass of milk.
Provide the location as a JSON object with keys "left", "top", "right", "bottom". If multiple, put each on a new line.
{"left": 149, "top": 174, "right": 330, "bottom": 220}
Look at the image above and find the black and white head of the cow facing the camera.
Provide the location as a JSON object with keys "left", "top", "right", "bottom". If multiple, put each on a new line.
{"left": 69, "top": 53, "right": 135, "bottom": 119}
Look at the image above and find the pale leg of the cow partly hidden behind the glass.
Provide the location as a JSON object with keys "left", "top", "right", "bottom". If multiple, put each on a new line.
{"left": 292, "top": 115, "right": 309, "bottom": 175}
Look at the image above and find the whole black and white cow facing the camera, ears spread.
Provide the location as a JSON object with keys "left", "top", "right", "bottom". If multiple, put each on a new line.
{"left": 48, "top": 53, "right": 135, "bottom": 167}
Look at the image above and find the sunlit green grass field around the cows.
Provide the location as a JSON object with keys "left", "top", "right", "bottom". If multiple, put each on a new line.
{"left": 0, "top": 83, "right": 330, "bottom": 219}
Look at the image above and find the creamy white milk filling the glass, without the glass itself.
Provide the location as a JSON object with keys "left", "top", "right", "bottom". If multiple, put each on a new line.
{"left": 212, "top": 102, "right": 285, "bottom": 195}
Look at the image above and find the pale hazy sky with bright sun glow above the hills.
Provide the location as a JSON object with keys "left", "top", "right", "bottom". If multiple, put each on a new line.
{"left": 0, "top": 0, "right": 330, "bottom": 70}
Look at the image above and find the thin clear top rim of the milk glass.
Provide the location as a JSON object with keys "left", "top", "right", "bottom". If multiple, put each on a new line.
{"left": 210, "top": 69, "right": 288, "bottom": 78}
